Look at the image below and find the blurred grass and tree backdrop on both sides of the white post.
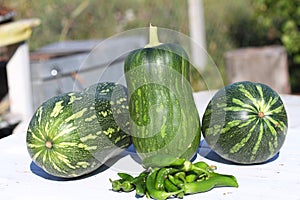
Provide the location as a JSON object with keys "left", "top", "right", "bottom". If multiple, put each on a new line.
{"left": 5, "top": 0, "right": 300, "bottom": 93}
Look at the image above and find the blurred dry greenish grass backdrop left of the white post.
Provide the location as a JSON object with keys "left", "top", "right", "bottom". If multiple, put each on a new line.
{"left": 7, "top": 0, "right": 188, "bottom": 50}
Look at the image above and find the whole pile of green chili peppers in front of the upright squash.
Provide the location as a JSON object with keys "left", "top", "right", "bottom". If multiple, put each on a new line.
{"left": 110, "top": 158, "right": 238, "bottom": 200}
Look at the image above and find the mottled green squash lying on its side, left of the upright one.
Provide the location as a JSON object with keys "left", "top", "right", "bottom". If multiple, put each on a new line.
{"left": 26, "top": 82, "right": 131, "bottom": 178}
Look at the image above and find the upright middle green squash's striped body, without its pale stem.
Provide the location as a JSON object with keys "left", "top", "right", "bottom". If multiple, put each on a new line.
{"left": 125, "top": 44, "right": 200, "bottom": 163}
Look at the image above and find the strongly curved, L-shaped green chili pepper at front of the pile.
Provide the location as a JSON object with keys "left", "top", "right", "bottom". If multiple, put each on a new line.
{"left": 146, "top": 169, "right": 183, "bottom": 200}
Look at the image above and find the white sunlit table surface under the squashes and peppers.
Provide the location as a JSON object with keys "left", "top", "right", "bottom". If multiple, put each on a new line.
{"left": 0, "top": 92, "right": 300, "bottom": 200}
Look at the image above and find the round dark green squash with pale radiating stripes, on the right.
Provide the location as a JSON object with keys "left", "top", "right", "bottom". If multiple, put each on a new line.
{"left": 202, "top": 81, "right": 288, "bottom": 164}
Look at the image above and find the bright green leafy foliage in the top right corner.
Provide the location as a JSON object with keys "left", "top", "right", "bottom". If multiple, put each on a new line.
{"left": 253, "top": 0, "right": 300, "bottom": 64}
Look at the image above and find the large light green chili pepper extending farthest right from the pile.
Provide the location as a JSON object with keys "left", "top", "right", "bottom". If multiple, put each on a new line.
{"left": 183, "top": 173, "right": 238, "bottom": 194}
